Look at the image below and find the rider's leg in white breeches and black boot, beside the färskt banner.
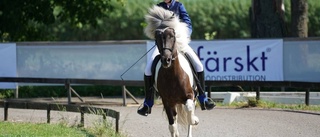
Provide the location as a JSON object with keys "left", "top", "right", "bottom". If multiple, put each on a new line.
{"left": 185, "top": 46, "right": 215, "bottom": 110}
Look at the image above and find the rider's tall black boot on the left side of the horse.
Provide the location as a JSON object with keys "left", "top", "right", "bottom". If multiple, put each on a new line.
{"left": 137, "top": 75, "right": 154, "bottom": 116}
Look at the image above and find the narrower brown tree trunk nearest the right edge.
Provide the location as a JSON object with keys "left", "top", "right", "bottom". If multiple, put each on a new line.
{"left": 291, "top": 0, "right": 308, "bottom": 38}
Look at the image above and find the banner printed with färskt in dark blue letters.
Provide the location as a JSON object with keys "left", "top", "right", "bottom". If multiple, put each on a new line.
{"left": 190, "top": 39, "right": 283, "bottom": 81}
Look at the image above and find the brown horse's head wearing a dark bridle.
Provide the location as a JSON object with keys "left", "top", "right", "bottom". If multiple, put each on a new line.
{"left": 155, "top": 27, "right": 178, "bottom": 68}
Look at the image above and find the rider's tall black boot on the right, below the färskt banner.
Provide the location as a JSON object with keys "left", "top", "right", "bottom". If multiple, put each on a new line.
{"left": 197, "top": 71, "right": 216, "bottom": 110}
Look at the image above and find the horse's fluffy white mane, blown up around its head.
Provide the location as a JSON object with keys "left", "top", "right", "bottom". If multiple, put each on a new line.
{"left": 144, "top": 5, "right": 190, "bottom": 50}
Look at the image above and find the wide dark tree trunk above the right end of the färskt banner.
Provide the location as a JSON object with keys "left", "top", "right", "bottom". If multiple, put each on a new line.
{"left": 250, "top": 0, "right": 287, "bottom": 38}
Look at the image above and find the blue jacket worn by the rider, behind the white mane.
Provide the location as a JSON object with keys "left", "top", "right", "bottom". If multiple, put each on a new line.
{"left": 157, "top": 0, "right": 192, "bottom": 36}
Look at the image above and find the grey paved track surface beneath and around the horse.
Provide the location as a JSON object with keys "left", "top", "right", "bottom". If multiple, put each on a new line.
{"left": 0, "top": 97, "right": 320, "bottom": 137}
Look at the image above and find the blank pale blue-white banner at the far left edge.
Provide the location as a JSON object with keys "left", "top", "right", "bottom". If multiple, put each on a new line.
{"left": 0, "top": 43, "right": 17, "bottom": 89}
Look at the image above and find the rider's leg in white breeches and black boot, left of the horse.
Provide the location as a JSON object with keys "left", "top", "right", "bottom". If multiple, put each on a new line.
{"left": 137, "top": 48, "right": 159, "bottom": 116}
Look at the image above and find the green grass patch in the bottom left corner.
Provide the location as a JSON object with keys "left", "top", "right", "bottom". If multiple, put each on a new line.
{"left": 0, "top": 121, "right": 125, "bottom": 137}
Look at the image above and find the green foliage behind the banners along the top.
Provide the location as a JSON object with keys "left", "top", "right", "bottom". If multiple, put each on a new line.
{"left": 0, "top": 0, "right": 320, "bottom": 41}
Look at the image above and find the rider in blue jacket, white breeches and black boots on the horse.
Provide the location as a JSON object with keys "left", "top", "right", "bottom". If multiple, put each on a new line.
{"left": 138, "top": 0, "right": 215, "bottom": 116}
